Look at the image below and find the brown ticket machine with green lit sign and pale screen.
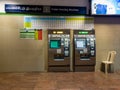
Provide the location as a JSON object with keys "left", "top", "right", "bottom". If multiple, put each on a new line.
{"left": 74, "top": 30, "right": 96, "bottom": 72}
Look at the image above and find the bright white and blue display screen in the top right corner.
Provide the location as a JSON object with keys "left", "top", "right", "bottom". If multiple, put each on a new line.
{"left": 91, "top": 0, "right": 120, "bottom": 15}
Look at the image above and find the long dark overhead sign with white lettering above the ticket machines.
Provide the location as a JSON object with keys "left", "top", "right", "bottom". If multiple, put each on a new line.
{"left": 5, "top": 4, "right": 87, "bottom": 15}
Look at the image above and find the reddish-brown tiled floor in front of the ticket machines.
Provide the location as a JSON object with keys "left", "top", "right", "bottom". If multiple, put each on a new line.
{"left": 0, "top": 72, "right": 120, "bottom": 90}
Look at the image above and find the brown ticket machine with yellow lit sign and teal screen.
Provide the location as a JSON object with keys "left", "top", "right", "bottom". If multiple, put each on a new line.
{"left": 48, "top": 30, "right": 70, "bottom": 71}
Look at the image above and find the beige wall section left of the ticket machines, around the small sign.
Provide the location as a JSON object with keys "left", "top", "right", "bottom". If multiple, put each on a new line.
{"left": 0, "top": 16, "right": 46, "bottom": 72}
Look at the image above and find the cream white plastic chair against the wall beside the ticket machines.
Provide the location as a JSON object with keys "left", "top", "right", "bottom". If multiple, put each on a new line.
{"left": 102, "top": 51, "right": 116, "bottom": 74}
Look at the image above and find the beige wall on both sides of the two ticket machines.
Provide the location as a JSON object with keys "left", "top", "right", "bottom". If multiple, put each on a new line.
{"left": 0, "top": 15, "right": 120, "bottom": 72}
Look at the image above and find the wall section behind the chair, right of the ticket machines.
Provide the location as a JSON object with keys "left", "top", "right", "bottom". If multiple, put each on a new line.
{"left": 94, "top": 17, "right": 120, "bottom": 71}
